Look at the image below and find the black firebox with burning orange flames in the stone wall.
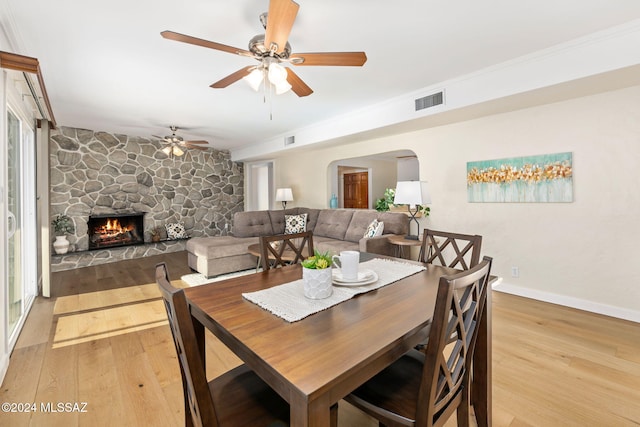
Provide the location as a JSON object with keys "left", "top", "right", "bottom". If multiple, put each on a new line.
{"left": 87, "top": 213, "right": 144, "bottom": 250}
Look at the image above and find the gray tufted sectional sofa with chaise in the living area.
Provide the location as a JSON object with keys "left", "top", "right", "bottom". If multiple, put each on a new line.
{"left": 187, "top": 207, "right": 409, "bottom": 277}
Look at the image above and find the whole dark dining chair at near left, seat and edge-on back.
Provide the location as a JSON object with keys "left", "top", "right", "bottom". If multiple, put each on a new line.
{"left": 156, "top": 263, "right": 289, "bottom": 427}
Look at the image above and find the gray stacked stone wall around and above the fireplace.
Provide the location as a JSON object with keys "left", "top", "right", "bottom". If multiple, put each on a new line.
{"left": 49, "top": 127, "right": 244, "bottom": 251}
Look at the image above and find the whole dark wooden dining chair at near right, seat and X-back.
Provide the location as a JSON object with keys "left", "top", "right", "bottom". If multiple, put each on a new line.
{"left": 345, "top": 257, "right": 492, "bottom": 427}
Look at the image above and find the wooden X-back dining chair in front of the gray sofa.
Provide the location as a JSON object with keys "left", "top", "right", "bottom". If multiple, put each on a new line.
{"left": 260, "top": 230, "right": 313, "bottom": 270}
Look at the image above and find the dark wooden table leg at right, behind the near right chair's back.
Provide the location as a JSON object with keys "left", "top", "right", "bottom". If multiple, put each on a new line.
{"left": 471, "top": 285, "right": 492, "bottom": 427}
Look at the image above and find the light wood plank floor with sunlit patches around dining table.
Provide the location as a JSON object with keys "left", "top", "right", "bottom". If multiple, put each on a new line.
{"left": 0, "top": 252, "right": 640, "bottom": 427}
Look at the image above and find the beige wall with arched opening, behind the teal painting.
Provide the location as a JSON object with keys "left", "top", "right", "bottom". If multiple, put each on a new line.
{"left": 268, "top": 86, "right": 640, "bottom": 321}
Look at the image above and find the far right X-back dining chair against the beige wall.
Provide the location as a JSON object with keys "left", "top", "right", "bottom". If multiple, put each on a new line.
{"left": 420, "top": 229, "right": 482, "bottom": 270}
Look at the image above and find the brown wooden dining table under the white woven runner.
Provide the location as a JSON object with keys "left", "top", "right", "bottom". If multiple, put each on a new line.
{"left": 185, "top": 254, "right": 491, "bottom": 427}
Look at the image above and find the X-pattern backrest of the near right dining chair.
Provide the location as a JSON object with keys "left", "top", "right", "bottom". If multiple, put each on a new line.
{"left": 416, "top": 257, "right": 492, "bottom": 426}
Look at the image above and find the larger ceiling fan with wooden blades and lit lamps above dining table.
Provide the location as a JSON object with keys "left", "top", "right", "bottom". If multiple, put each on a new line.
{"left": 160, "top": 0, "right": 367, "bottom": 96}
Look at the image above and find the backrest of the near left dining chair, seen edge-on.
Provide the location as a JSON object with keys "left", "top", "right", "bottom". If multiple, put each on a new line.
{"left": 156, "top": 263, "right": 218, "bottom": 427}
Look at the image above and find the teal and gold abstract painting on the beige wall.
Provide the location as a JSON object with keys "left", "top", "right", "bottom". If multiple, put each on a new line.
{"left": 467, "top": 153, "right": 573, "bottom": 203}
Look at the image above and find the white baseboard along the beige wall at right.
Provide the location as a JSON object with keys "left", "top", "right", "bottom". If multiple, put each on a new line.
{"left": 492, "top": 280, "right": 640, "bottom": 323}
